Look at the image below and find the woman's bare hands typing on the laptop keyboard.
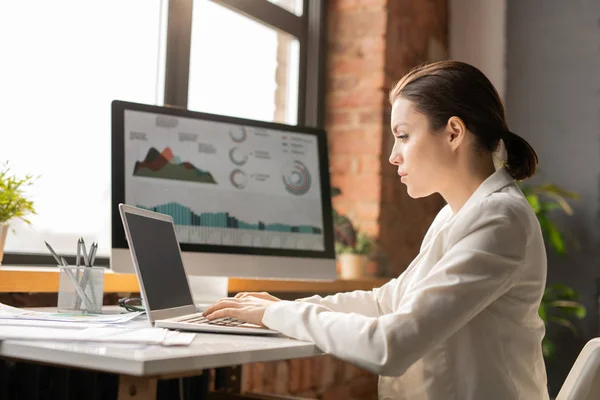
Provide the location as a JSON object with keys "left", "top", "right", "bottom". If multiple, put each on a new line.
{"left": 202, "top": 295, "right": 279, "bottom": 326}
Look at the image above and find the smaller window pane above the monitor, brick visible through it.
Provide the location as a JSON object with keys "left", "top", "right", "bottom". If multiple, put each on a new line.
{"left": 188, "top": 0, "right": 300, "bottom": 125}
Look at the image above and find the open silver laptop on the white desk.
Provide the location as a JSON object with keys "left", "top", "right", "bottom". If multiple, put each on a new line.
{"left": 119, "top": 204, "right": 279, "bottom": 335}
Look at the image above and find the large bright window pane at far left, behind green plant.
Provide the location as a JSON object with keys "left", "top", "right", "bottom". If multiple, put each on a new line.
{"left": 0, "top": 0, "right": 164, "bottom": 256}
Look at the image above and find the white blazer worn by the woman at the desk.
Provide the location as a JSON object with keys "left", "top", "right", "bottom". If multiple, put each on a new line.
{"left": 262, "top": 168, "right": 548, "bottom": 400}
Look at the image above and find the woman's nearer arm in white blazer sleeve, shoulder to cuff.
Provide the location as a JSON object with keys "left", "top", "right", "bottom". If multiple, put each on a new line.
{"left": 262, "top": 211, "right": 526, "bottom": 376}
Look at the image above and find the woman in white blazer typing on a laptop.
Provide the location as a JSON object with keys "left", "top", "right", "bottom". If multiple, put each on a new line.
{"left": 205, "top": 61, "right": 548, "bottom": 400}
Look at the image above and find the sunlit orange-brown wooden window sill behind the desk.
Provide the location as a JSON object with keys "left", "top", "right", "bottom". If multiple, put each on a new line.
{"left": 0, "top": 266, "right": 389, "bottom": 294}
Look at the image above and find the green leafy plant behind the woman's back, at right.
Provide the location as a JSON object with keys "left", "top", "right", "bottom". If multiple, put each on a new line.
{"left": 522, "top": 184, "right": 586, "bottom": 359}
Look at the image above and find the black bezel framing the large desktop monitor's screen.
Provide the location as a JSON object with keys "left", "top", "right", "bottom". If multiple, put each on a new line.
{"left": 111, "top": 100, "right": 335, "bottom": 260}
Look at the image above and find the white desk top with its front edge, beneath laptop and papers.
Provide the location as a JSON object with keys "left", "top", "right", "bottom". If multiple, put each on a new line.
{"left": 0, "top": 314, "right": 323, "bottom": 376}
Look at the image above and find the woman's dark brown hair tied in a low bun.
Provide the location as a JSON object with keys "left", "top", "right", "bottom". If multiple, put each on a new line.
{"left": 390, "top": 60, "right": 538, "bottom": 180}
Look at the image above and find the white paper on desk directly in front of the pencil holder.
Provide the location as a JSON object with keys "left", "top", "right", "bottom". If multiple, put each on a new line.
{"left": 0, "top": 303, "right": 143, "bottom": 324}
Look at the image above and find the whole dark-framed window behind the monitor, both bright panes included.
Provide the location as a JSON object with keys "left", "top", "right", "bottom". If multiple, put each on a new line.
{"left": 0, "top": 0, "right": 324, "bottom": 265}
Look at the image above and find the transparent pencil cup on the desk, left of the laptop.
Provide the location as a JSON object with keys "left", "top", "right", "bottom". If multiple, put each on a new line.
{"left": 57, "top": 266, "right": 105, "bottom": 314}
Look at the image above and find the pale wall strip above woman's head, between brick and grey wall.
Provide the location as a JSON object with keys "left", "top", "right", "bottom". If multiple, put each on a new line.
{"left": 449, "top": 0, "right": 506, "bottom": 100}
